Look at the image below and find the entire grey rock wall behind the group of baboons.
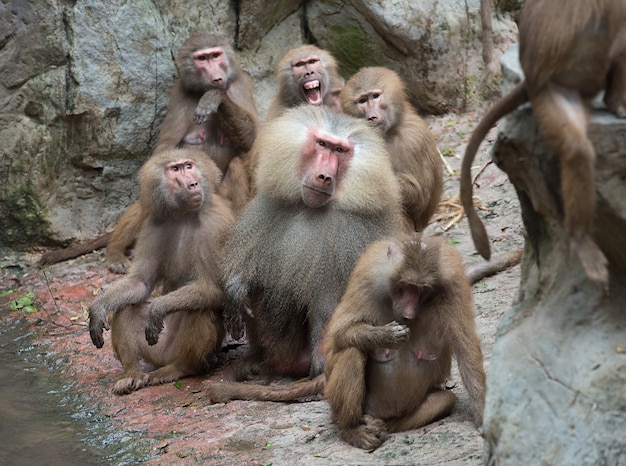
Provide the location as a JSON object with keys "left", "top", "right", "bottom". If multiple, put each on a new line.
{"left": 0, "top": 0, "right": 516, "bottom": 247}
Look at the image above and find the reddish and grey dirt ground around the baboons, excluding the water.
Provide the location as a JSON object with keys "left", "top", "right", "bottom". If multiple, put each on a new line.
{"left": 0, "top": 107, "right": 524, "bottom": 465}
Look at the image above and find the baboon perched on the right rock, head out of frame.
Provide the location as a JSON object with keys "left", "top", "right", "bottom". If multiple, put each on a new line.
{"left": 461, "top": 0, "right": 626, "bottom": 287}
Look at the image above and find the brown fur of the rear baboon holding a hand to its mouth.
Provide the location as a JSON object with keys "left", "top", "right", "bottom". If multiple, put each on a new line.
{"left": 106, "top": 34, "right": 258, "bottom": 273}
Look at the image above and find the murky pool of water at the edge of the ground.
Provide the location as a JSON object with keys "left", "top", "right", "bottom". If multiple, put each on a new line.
{"left": 0, "top": 321, "right": 150, "bottom": 466}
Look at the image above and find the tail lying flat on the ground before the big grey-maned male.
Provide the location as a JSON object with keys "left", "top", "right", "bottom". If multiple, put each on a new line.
{"left": 203, "top": 374, "right": 324, "bottom": 403}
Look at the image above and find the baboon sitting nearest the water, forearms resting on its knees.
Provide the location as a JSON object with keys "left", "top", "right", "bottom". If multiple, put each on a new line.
{"left": 89, "top": 149, "right": 234, "bottom": 395}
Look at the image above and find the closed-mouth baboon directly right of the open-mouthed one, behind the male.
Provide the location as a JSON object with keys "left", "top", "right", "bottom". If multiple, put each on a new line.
{"left": 341, "top": 67, "right": 443, "bottom": 231}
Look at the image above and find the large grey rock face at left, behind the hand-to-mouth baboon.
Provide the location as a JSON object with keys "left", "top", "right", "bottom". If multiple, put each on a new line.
{"left": 0, "top": 0, "right": 236, "bottom": 246}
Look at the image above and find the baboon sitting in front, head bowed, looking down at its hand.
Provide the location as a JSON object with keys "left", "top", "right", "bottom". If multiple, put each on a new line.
{"left": 205, "top": 233, "right": 485, "bottom": 449}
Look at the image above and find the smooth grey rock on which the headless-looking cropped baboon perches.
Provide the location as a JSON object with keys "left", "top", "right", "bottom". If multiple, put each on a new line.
{"left": 484, "top": 46, "right": 626, "bottom": 465}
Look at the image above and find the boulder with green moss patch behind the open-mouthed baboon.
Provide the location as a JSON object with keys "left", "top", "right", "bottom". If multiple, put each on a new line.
{"left": 306, "top": 0, "right": 517, "bottom": 114}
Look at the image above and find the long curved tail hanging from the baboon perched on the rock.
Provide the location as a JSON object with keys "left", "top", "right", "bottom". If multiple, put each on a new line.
{"left": 460, "top": 81, "right": 528, "bottom": 260}
